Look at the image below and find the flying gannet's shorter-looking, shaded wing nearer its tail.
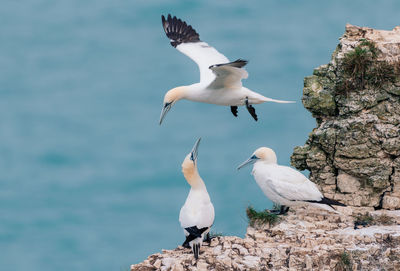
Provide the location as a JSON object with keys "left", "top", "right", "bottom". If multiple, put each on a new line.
{"left": 208, "top": 59, "right": 249, "bottom": 89}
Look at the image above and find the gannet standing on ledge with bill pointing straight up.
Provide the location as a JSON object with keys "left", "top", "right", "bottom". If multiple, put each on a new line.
{"left": 179, "top": 138, "right": 214, "bottom": 259}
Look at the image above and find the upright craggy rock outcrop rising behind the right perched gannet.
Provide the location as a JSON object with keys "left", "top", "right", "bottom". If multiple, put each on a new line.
{"left": 291, "top": 25, "right": 400, "bottom": 209}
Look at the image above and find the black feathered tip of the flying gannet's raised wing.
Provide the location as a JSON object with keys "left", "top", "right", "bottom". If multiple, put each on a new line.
{"left": 161, "top": 14, "right": 200, "bottom": 48}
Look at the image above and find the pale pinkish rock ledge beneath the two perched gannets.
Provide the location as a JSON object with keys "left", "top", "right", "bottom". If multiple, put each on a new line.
{"left": 131, "top": 209, "right": 400, "bottom": 271}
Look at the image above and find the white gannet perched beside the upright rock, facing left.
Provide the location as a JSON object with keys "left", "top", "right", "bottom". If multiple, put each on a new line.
{"left": 238, "top": 147, "right": 346, "bottom": 214}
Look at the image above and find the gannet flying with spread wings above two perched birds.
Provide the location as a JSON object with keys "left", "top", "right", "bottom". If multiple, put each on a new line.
{"left": 160, "top": 14, "right": 291, "bottom": 124}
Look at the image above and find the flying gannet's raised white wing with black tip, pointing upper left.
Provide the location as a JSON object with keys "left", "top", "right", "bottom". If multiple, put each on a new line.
{"left": 161, "top": 14, "right": 229, "bottom": 85}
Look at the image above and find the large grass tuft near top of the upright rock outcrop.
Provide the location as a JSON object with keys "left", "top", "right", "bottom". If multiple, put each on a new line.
{"left": 337, "top": 40, "right": 399, "bottom": 93}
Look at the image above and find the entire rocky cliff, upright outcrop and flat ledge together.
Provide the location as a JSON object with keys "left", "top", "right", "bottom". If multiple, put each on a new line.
{"left": 131, "top": 25, "right": 400, "bottom": 271}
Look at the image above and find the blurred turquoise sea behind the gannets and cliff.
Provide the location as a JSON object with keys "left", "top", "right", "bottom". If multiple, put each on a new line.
{"left": 0, "top": 0, "right": 400, "bottom": 271}
